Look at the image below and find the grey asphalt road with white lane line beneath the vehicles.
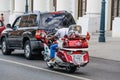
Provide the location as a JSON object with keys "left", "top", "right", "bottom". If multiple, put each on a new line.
{"left": 0, "top": 51, "right": 120, "bottom": 80}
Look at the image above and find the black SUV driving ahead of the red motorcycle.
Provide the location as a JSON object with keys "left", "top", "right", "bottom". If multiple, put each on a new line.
{"left": 1, "top": 11, "right": 75, "bottom": 59}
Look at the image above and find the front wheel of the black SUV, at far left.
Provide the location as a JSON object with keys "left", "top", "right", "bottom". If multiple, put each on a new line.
{"left": 1, "top": 38, "right": 12, "bottom": 55}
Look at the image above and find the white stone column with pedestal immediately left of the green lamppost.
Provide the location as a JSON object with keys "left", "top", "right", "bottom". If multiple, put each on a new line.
{"left": 77, "top": 0, "right": 102, "bottom": 34}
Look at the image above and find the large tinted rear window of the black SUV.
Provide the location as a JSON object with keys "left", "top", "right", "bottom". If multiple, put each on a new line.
{"left": 41, "top": 13, "right": 75, "bottom": 27}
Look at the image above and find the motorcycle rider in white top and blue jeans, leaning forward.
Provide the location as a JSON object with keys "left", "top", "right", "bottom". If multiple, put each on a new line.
{"left": 50, "top": 25, "right": 82, "bottom": 62}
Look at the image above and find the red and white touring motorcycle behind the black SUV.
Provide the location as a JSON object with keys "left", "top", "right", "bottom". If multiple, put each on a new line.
{"left": 42, "top": 25, "right": 90, "bottom": 73}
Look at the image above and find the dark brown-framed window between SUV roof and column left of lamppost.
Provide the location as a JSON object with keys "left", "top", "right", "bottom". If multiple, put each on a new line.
{"left": 78, "top": 0, "right": 87, "bottom": 17}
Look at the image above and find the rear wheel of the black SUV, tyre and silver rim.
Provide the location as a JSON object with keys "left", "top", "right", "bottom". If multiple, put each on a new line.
{"left": 24, "top": 40, "right": 33, "bottom": 60}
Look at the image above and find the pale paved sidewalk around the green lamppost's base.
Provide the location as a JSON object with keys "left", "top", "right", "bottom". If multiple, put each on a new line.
{"left": 89, "top": 32, "right": 120, "bottom": 61}
